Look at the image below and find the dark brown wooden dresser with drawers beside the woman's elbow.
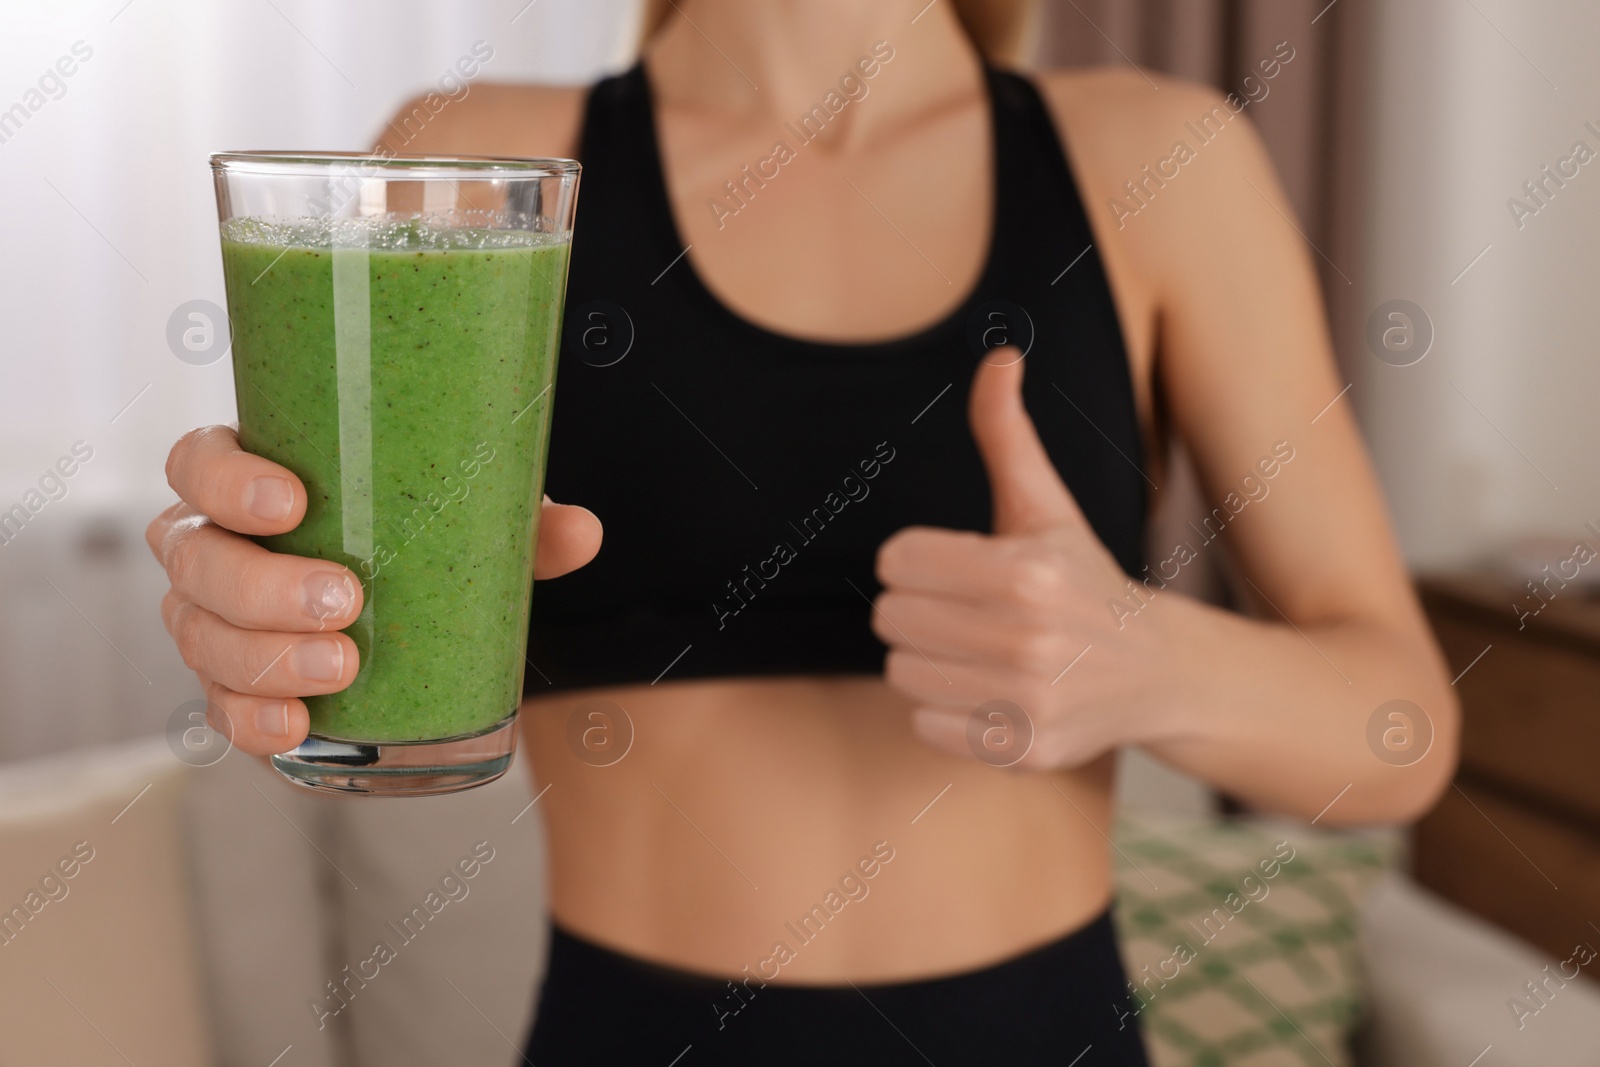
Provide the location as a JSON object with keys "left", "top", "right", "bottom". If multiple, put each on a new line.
{"left": 1413, "top": 574, "right": 1600, "bottom": 973}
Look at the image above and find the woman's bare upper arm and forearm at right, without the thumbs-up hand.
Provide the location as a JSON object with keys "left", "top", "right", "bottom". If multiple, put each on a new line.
{"left": 1128, "top": 91, "right": 1459, "bottom": 822}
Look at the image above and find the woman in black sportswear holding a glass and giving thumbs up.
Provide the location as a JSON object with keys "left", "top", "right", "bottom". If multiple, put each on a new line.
{"left": 150, "top": 0, "right": 1456, "bottom": 1064}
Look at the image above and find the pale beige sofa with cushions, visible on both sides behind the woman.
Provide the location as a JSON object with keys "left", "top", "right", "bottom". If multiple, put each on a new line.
{"left": 0, "top": 737, "right": 1600, "bottom": 1067}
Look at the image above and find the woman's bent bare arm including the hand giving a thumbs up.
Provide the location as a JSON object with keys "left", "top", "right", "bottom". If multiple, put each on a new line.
{"left": 878, "top": 83, "right": 1459, "bottom": 822}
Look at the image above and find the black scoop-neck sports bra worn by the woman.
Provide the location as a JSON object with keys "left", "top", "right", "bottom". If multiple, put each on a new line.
{"left": 525, "top": 66, "right": 1146, "bottom": 694}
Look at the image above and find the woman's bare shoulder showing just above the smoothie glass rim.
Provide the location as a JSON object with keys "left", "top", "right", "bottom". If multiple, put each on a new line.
{"left": 378, "top": 82, "right": 589, "bottom": 157}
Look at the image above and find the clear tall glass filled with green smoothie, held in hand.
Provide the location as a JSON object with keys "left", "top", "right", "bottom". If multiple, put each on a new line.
{"left": 211, "top": 152, "right": 579, "bottom": 795}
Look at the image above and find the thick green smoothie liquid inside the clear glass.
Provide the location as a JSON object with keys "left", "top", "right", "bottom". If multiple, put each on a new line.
{"left": 222, "top": 218, "right": 568, "bottom": 742}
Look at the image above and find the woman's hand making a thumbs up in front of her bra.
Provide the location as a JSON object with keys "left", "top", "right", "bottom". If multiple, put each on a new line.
{"left": 872, "top": 350, "right": 1170, "bottom": 768}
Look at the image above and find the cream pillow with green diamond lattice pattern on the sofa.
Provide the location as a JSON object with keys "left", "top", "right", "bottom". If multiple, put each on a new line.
{"left": 1110, "top": 813, "right": 1398, "bottom": 1067}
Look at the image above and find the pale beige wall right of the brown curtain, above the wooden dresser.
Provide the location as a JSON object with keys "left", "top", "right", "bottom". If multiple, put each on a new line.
{"left": 1350, "top": 0, "right": 1600, "bottom": 566}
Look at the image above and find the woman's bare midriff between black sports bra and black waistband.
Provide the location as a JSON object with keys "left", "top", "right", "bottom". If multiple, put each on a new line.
{"left": 522, "top": 675, "right": 1114, "bottom": 984}
